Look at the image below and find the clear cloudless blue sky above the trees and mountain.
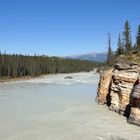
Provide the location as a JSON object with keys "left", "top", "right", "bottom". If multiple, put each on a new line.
{"left": 0, "top": 0, "right": 140, "bottom": 56}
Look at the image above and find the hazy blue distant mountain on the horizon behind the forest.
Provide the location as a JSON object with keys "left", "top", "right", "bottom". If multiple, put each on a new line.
{"left": 65, "top": 52, "right": 107, "bottom": 62}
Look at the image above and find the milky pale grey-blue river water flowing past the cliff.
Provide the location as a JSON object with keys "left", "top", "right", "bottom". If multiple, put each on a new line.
{"left": 0, "top": 72, "right": 140, "bottom": 140}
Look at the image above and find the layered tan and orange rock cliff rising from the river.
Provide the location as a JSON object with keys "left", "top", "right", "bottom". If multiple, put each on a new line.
{"left": 96, "top": 64, "right": 140, "bottom": 126}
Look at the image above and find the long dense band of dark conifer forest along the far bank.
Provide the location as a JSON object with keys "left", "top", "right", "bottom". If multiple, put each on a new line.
{"left": 0, "top": 53, "right": 100, "bottom": 77}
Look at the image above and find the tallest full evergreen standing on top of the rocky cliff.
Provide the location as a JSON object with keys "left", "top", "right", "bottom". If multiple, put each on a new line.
{"left": 123, "top": 21, "right": 132, "bottom": 53}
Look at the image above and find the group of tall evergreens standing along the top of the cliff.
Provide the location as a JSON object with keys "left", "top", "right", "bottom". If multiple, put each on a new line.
{"left": 107, "top": 21, "right": 140, "bottom": 65}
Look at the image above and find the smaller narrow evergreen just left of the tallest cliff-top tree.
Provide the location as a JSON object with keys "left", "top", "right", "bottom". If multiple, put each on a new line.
{"left": 116, "top": 34, "right": 124, "bottom": 56}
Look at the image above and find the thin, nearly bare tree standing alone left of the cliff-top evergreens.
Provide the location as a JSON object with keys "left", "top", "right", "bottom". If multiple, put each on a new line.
{"left": 107, "top": 33, "right": 113, "bottom": 65}
